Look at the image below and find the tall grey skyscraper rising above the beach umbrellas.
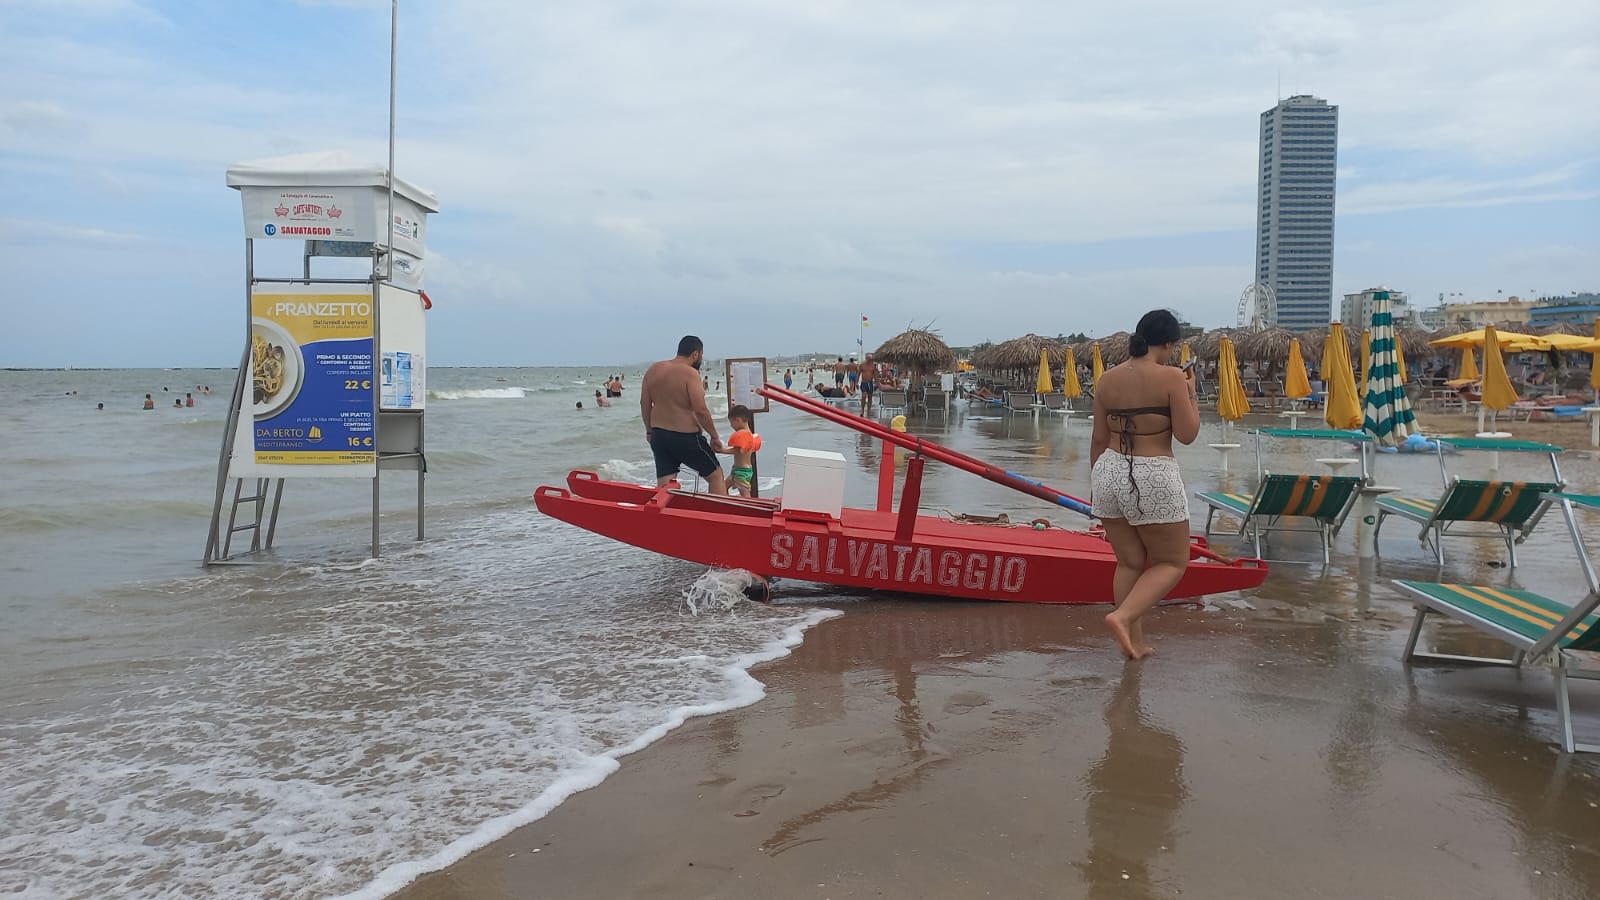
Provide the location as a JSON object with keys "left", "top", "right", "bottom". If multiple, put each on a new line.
{"left": 1256, "top": 94, "right": 1339, "bottom": 330}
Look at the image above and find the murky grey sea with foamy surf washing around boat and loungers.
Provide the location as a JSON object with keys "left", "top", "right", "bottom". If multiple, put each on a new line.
{"left": 0, "top": 361, "right": 1600, "bottom": 898}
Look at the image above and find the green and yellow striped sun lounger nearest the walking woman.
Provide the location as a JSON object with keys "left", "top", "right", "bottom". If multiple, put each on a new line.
{"left": 1195, "top": 474, "right": 1363, "bottom": 565}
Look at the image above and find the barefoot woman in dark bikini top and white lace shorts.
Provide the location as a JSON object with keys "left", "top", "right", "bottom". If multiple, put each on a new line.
{"left": 1090, "top": 309, "right": 1200, "bottom": 660}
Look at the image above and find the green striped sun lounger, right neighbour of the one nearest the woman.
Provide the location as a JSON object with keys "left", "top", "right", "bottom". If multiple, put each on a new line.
{"left": 1373, "top": 479, "right": 1562, "bottom": 569}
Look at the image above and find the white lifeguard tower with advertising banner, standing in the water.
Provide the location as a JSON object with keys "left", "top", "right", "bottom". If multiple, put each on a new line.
{"left": 205, "top": 154, "right": 438, "bottom": 565}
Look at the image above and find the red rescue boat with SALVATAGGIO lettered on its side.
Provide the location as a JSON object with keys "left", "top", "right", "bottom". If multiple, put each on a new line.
{"left": 534, "top": 384, "right": 1267, "bottom": 604}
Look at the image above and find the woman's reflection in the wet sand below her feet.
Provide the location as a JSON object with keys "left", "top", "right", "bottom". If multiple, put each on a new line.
{"left": 1077, "top": 663, "right": 1187, "bottom": 898}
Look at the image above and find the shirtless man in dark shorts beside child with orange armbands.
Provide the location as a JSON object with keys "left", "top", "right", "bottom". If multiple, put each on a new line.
{"left": 638, "top": 335, "right": 728, "bottom": 495}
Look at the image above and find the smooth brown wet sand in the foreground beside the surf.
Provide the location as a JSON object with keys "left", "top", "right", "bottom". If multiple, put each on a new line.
{"left": 400, "top": 576, "right": 1600, "bottom": 900}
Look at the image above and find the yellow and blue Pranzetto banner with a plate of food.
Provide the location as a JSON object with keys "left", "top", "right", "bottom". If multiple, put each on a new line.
{"left": 250, "top": 285, "right": 378, "bottom": 469}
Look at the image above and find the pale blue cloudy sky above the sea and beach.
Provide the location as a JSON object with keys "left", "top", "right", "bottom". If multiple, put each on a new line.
{"left": 0, "top": 0, "right": 1600, "bottom": 365}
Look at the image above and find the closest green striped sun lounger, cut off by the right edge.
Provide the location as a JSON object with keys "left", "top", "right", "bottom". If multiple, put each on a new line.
{"left": 1395, "top": 581, "right": 1600, "bottom": 753}
